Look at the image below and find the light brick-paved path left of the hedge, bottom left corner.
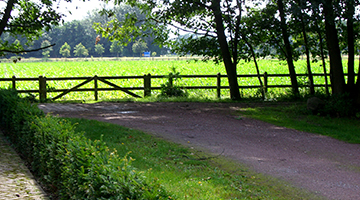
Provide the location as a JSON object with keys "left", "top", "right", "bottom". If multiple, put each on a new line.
{"left": 0, "top": 131, "right": 47, "bottom": 200}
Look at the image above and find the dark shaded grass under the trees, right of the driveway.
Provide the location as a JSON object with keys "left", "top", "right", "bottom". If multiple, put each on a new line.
{"left": 239, "top": 102, "right": 360, "bottom": 144}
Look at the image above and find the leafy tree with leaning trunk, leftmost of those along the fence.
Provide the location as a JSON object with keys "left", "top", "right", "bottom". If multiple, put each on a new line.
{"left": 96, "top": 0, "right": 244, "bottom": 100}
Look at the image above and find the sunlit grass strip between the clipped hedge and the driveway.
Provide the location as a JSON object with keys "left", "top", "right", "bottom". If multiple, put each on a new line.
{"left": 67, "top": 118, "right": 320, "bottom": 200}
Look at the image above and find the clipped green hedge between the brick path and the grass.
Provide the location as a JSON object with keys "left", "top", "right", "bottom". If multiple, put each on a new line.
{"left": 0, "top": 89, "right": 171, "bottom": 199}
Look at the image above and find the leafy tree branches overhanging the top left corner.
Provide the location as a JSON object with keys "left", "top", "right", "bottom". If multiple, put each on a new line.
{"left": 0, "top": 0, "right": 62, "bottom": 56}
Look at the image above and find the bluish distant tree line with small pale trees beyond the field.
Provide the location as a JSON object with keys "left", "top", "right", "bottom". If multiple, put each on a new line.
{"left": 1, "top": 5, "right": 168, "bottom": 59}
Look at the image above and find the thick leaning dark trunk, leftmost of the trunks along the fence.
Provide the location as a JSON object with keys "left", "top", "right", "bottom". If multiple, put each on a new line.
{"left": 212, "top": 0, "right": 241, "bottom": 100}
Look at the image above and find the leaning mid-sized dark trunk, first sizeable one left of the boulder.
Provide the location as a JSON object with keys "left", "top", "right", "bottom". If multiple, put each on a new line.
{"left": 277, "top": 0, "right": 300, "bottom": 95}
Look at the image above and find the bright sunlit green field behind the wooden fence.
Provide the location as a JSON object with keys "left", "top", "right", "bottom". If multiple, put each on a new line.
{"left": 0, "top": 59, "right": 356, "bottom": 100}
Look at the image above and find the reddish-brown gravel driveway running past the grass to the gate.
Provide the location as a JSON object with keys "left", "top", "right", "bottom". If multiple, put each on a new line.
{"left": 39, "top": 102, "right": 360, "bottom": 200}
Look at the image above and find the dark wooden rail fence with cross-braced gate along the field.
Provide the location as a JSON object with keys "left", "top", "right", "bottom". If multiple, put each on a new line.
{"left": 0, "top": 72, "right": 329, "bottom": 101}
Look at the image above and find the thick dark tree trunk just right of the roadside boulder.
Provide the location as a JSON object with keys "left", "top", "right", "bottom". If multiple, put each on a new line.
{"left": 323, "top": 0, "right": 345, "bottom": 94}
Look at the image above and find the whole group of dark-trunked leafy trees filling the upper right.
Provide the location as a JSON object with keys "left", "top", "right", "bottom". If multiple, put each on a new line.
{"left": 96, "top": 0, "right": 360, "bottom": 105}
